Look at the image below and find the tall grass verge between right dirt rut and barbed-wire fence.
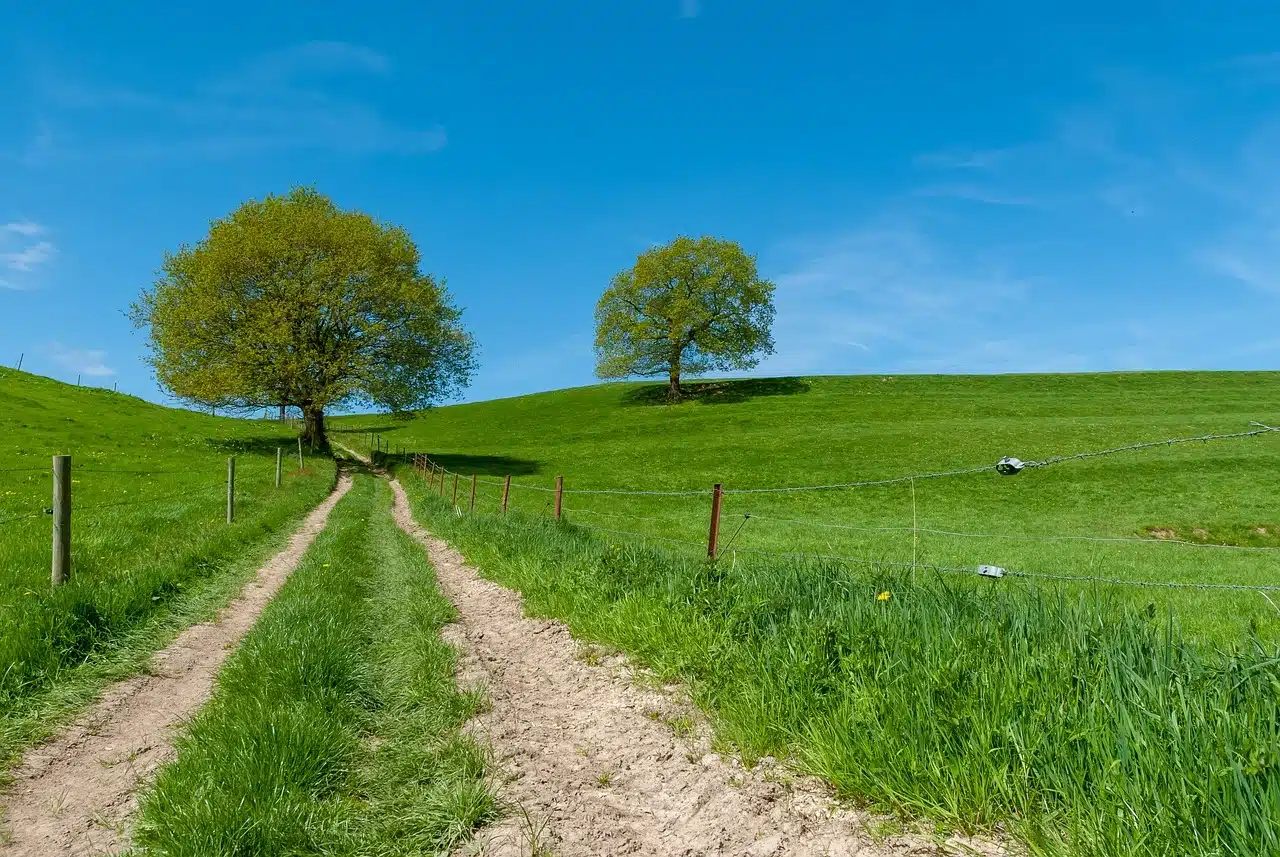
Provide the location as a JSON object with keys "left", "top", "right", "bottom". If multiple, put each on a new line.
{"left": 404, "top": 476, "right": 1280, "bottom": 857}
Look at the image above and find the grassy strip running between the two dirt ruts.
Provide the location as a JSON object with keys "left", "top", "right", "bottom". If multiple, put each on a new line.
{"left": 127, "top": 476, "right": 495, "bottom": 857}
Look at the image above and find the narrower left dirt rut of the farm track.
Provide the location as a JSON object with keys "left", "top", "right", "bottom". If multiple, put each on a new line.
{"left": 0, "top": 473, "right": 352, "bottom": 857}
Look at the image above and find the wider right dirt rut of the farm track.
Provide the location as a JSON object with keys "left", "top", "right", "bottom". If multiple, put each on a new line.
{"left": 392, "top": 481, "right": 1001, "bottom": 857}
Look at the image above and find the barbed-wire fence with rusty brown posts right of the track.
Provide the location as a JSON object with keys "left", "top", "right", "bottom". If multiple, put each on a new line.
{"left": 404, "top": 422, "right": 1280, "bottom": 592}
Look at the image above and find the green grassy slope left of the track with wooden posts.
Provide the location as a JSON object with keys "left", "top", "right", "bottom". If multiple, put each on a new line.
{"left": 0, "top": 370, "right": 334, "bottom": 759}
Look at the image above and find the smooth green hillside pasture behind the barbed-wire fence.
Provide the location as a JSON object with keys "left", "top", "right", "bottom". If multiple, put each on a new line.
{"left": 333, "top": 372, "right": 1280, "bottom": 645}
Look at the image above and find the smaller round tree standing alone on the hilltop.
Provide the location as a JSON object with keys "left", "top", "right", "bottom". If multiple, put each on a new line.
{"left": 595, "top": 235, "right": 773, "bottom": 399}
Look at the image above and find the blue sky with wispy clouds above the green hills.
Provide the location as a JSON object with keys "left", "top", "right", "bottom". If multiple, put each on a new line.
{"left": 0, "top": 0, "right": 1280, "bottom": 399}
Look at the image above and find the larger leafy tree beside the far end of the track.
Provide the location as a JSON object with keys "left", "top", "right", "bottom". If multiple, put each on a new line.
{"left": 132, "top": 188, "right": 475, "bottom": 446}
